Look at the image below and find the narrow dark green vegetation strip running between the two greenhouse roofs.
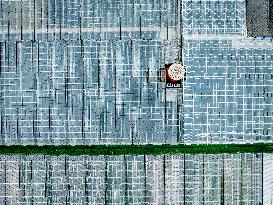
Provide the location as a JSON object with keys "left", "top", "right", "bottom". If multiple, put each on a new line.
{"left": 0, "top": 143, "right": 273, "bottom": 156}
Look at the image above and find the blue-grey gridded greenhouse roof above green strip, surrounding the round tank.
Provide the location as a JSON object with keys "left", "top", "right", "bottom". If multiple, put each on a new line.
{"left": 0, "top": 0, "right": 273, "bottom": 145}
